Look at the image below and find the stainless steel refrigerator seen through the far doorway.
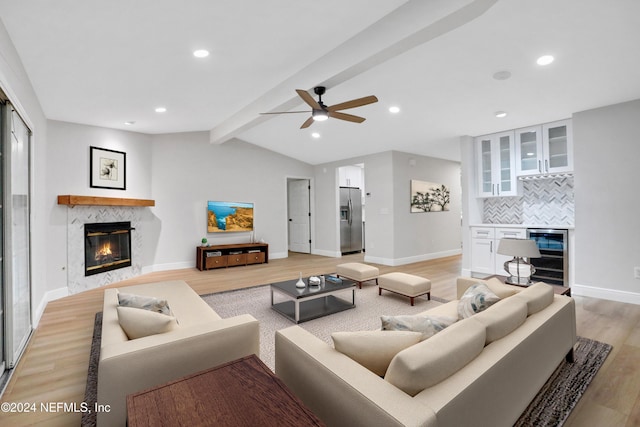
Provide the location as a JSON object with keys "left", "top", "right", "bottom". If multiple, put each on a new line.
{"left": 340, "top": 187, "right": 362, "bottom": 254}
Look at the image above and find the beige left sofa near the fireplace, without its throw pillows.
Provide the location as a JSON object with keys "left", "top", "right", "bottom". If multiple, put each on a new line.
{"left": 97, "top": 280, "right": 260, "bottom": 427}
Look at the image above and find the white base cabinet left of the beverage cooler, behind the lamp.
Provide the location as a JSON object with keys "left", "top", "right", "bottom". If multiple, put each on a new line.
{"left": 471, "top": 225, "right": 527, "bottom": 276}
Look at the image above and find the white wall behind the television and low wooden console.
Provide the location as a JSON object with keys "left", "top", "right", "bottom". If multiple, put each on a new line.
{"left": 151, "top": 132, "right": 313, "bottom": 270}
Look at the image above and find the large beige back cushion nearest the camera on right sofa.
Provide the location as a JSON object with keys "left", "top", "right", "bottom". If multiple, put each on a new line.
{"left": 384, "top": 319, "right": 486, "bottom": 396}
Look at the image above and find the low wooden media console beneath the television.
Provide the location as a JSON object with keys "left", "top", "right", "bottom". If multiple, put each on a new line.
{"left": 196, "top": 243, "right": 269, "bottom": 270}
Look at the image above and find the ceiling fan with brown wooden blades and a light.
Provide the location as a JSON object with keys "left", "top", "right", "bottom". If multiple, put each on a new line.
{"left": 260, "top": 86, "right": 378, "bottom": 129}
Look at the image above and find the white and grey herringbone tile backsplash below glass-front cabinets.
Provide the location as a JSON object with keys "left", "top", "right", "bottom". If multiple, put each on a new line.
{"left": 482, "top": 176, "right": 575, "bottom": 226}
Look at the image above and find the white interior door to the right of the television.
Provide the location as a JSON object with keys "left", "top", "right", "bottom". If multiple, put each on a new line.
{"left": 287, "top": 179, "right": 311, "bottom": 254}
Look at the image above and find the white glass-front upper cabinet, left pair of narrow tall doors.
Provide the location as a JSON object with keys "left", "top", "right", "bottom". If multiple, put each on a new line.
{"left": 475, "top": 131, "right": 517, "bottom": 197}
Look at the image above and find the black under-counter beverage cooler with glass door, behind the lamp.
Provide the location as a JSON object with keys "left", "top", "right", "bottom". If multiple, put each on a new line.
{"left": 527, "top": 228, "right": 569, "bottom": 286}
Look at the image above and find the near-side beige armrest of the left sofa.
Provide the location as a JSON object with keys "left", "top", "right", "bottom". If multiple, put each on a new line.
{"left": 97, "top": 314, "right": 260, "bottom": 426}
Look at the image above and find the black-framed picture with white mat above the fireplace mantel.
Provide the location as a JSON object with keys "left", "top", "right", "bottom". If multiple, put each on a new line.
{"left": 89, "top": 147, "right": 127, "bottom": 190}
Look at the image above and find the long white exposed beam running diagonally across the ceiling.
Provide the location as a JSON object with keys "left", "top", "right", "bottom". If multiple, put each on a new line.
{"left": 209, "top": 0, "right": 498, "bottom": 144}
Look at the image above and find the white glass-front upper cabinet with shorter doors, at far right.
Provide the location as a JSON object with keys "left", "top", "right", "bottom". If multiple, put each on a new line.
{"left": 515, "top": 120, "right": 573, "bottom": 176}
